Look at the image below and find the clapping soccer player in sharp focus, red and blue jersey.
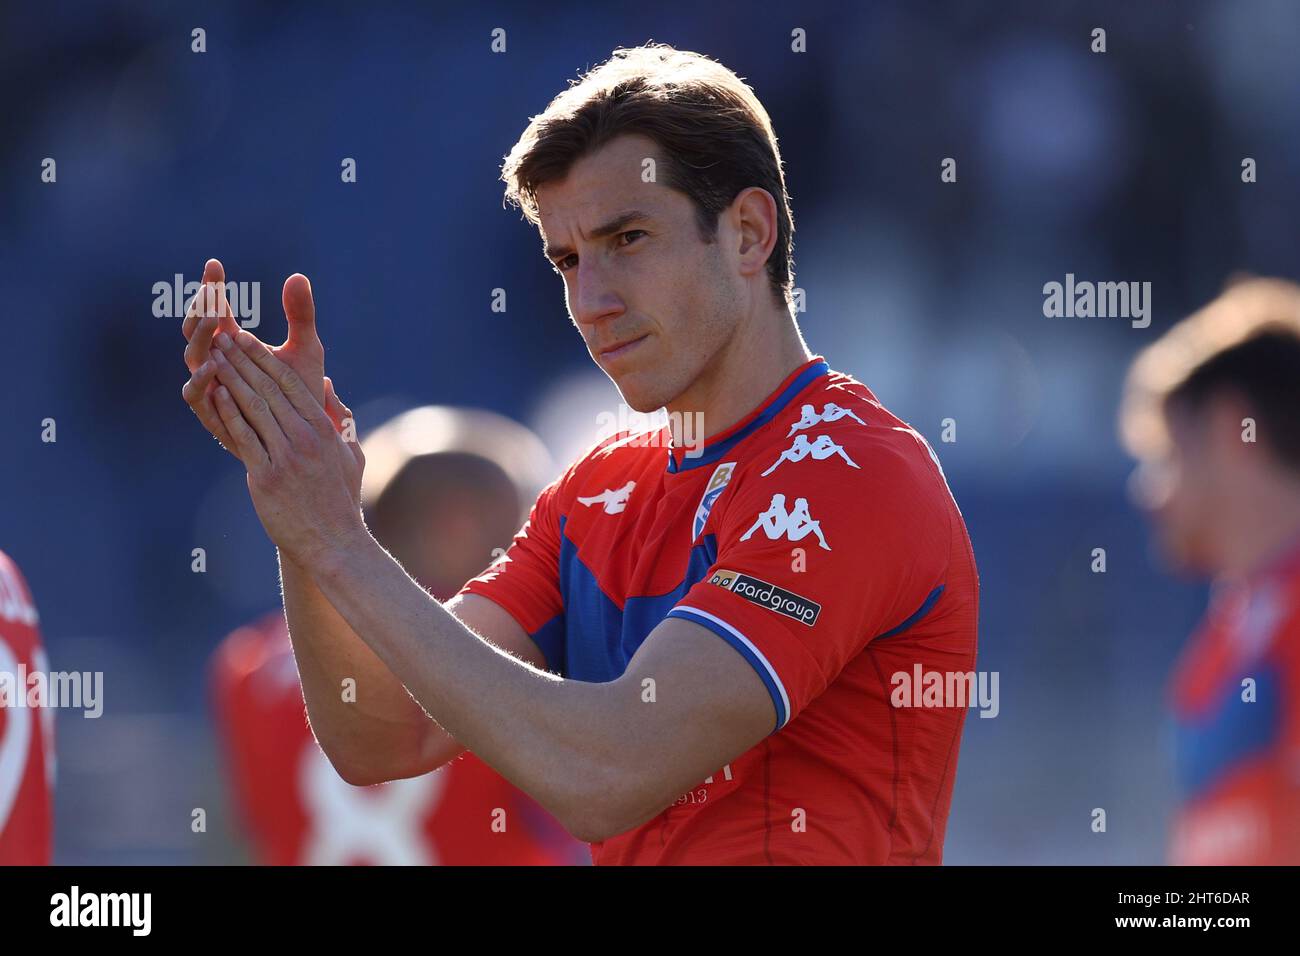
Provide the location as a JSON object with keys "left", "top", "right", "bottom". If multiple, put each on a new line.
{"left": 183, "top": 46, "right": 978, "bottom": 864}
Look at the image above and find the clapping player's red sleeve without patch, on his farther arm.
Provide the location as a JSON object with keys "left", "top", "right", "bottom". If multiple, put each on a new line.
{"left": 459, "top": 480, "right": 564, "bottom": 670}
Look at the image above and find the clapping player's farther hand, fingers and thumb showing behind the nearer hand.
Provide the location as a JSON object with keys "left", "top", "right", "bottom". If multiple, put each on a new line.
{"left": 181, "top": 259, "right": 332, "bottom": 457}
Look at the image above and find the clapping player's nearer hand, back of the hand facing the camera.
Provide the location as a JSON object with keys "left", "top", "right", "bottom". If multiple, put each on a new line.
{"left": 208, "top": 329, "right": 368, "bottom": 568}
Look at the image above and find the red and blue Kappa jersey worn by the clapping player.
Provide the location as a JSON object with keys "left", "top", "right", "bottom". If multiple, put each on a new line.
{"left": 464, "top": 358, "right": 978, "bottom": 864}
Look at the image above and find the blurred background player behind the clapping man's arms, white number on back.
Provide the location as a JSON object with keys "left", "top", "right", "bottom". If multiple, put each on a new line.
{"left": 212, "top": 407, "right": 588, "bottom": 865}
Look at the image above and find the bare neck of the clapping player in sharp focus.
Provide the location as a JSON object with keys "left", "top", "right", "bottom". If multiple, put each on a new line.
{"left": 667, "top": 306, "right": 813, "bottom": 446}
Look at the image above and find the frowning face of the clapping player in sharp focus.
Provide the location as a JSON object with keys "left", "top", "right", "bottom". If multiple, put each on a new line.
{"left": 537, "top": 135, "right": 742, "bottom": 412}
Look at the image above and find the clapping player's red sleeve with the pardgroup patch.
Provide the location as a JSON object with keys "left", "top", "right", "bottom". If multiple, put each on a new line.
{"left": 668, "top": 423, "right": 954, "bottom": 730}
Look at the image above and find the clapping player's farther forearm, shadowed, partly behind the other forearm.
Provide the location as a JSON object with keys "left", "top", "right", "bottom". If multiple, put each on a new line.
{"left": 280, "top": 553, "right": 463, "bottom": 783}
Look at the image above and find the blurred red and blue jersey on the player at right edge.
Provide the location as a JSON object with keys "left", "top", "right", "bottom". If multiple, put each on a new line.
{"left": 1170, "top": 535, "right": 1300, "bottom": 866}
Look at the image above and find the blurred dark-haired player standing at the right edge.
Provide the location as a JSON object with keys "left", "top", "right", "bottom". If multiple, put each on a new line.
{"left": 1121, "top": 280, "right": 1300, "bottom": 865}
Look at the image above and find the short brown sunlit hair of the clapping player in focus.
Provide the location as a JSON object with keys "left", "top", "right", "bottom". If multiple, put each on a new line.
{"left": 501, "top": 43, "right": 794, "bottom": 304}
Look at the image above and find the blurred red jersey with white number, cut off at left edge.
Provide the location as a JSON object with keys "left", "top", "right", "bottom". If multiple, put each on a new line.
{"left": 0, "top": 551, "right": 55, "bottom": 866}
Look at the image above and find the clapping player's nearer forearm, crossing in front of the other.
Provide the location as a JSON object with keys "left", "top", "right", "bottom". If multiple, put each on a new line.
{"left": 304, "top": 528, "right": 629, "bottom": 832}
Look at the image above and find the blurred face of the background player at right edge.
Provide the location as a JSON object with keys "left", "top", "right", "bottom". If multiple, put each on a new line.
{"left": 1135, "top": 405, "right": 1234, "bottom": 575}
